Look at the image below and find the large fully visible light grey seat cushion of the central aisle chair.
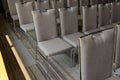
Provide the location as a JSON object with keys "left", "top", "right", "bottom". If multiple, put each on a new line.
{"left": 38, "top": 38, "right": 72, "bottom": 57}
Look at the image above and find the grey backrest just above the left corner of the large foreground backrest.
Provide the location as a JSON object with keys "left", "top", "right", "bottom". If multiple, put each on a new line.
{"left": 82, "top": 5, "right": 97, "bottom": 32}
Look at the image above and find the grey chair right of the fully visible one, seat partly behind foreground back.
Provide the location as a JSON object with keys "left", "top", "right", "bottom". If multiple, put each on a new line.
{"left": 59, "top": 7, "right": 82, "bottom": 65}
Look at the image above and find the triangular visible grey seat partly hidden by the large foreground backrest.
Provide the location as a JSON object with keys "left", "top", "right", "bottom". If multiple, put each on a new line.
{"left": 63, "top": 32, "right": 82, "bottom": 47}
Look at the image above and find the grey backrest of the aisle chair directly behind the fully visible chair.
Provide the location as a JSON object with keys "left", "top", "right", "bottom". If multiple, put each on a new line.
{"left": 16, "top": 2, "right": 33, "bottom": 25}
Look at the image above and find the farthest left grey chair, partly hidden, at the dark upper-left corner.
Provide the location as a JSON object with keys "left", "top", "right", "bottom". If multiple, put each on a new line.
{"left": 7, "top": 0, "right": 21, "bottom": 29}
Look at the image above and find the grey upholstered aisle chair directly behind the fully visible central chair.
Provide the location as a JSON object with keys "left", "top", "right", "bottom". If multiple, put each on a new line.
{"left": 16, "top": 2, "right": 34, "bottom": 32}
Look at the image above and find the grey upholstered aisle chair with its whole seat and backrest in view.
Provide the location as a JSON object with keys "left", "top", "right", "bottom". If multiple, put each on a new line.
{"left": 32, "top": 9, "right": 72, "bottom": 57}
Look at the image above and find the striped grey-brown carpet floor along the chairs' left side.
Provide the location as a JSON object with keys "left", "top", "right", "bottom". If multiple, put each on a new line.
{"left": 0, "top": 16, "right": 80, "bottom": 80}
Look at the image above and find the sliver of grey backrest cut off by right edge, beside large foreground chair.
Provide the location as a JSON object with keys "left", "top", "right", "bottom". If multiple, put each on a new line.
{"left": 115, "top": 25, "right": 120, "bottom": 68}
